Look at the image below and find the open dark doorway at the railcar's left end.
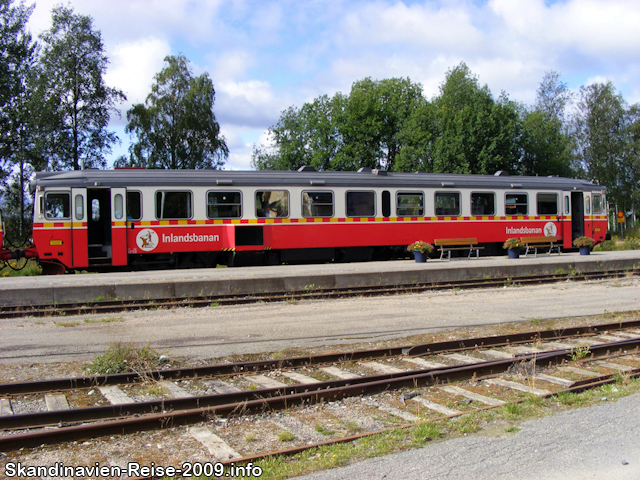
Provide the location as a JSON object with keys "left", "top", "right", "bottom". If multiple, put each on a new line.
{"left": 87, "top": 188, "right": 112, "bottom": 265}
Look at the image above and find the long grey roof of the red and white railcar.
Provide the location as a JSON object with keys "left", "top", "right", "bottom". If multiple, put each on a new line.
{"left": 33, "top": 167, "right": 606, "bottom": 190}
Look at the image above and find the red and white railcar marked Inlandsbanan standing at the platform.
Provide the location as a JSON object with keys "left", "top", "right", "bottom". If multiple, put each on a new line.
{"left": 25, "top": 167, "right": 607, "bottom": 272}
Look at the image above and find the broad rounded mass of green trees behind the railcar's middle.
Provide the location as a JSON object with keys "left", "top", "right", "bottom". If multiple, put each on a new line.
{"left": 252, "top": 78, "right": 424, "bottom": 170}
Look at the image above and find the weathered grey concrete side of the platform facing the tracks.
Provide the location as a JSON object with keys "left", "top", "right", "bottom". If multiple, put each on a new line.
{"left": 0, "top": 255, "right": 640, "bottom": 306}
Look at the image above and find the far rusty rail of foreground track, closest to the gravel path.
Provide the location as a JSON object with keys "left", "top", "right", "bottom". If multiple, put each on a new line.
{"left": 0, "top": 320, "right": 640, "bottom": 396}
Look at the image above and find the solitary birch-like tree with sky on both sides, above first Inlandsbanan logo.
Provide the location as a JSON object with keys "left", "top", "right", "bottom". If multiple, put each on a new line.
{"left": 116, "top": 55, "right": 229, "bottom": 169}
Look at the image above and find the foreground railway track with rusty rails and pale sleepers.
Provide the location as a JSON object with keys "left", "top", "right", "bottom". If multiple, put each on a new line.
{"left": 0, "top": 320, "right": 640, "bottom": 461}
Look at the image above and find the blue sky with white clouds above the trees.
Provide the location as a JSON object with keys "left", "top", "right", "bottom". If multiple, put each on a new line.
{"left": 26, "top": 0, "right": 640, "bottom": 170}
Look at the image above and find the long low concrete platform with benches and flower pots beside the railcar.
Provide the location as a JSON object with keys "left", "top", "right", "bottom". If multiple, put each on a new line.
{"left": 0, "top": 250, "right": 640, "bottom": 306}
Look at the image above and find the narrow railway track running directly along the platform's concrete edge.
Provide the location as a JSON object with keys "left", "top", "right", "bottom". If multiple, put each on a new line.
{"left": 0, "top": 268, "right": 640, "bottom": 319}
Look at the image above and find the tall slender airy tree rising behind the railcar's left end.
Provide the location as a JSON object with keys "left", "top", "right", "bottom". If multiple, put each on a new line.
{"left": 34, "top": 6, "right": 126, "bottom": 170}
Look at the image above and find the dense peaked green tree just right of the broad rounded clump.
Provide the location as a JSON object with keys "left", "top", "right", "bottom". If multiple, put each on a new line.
{"left": 433, "top": 62, "right": 522, "bottom": 174}
